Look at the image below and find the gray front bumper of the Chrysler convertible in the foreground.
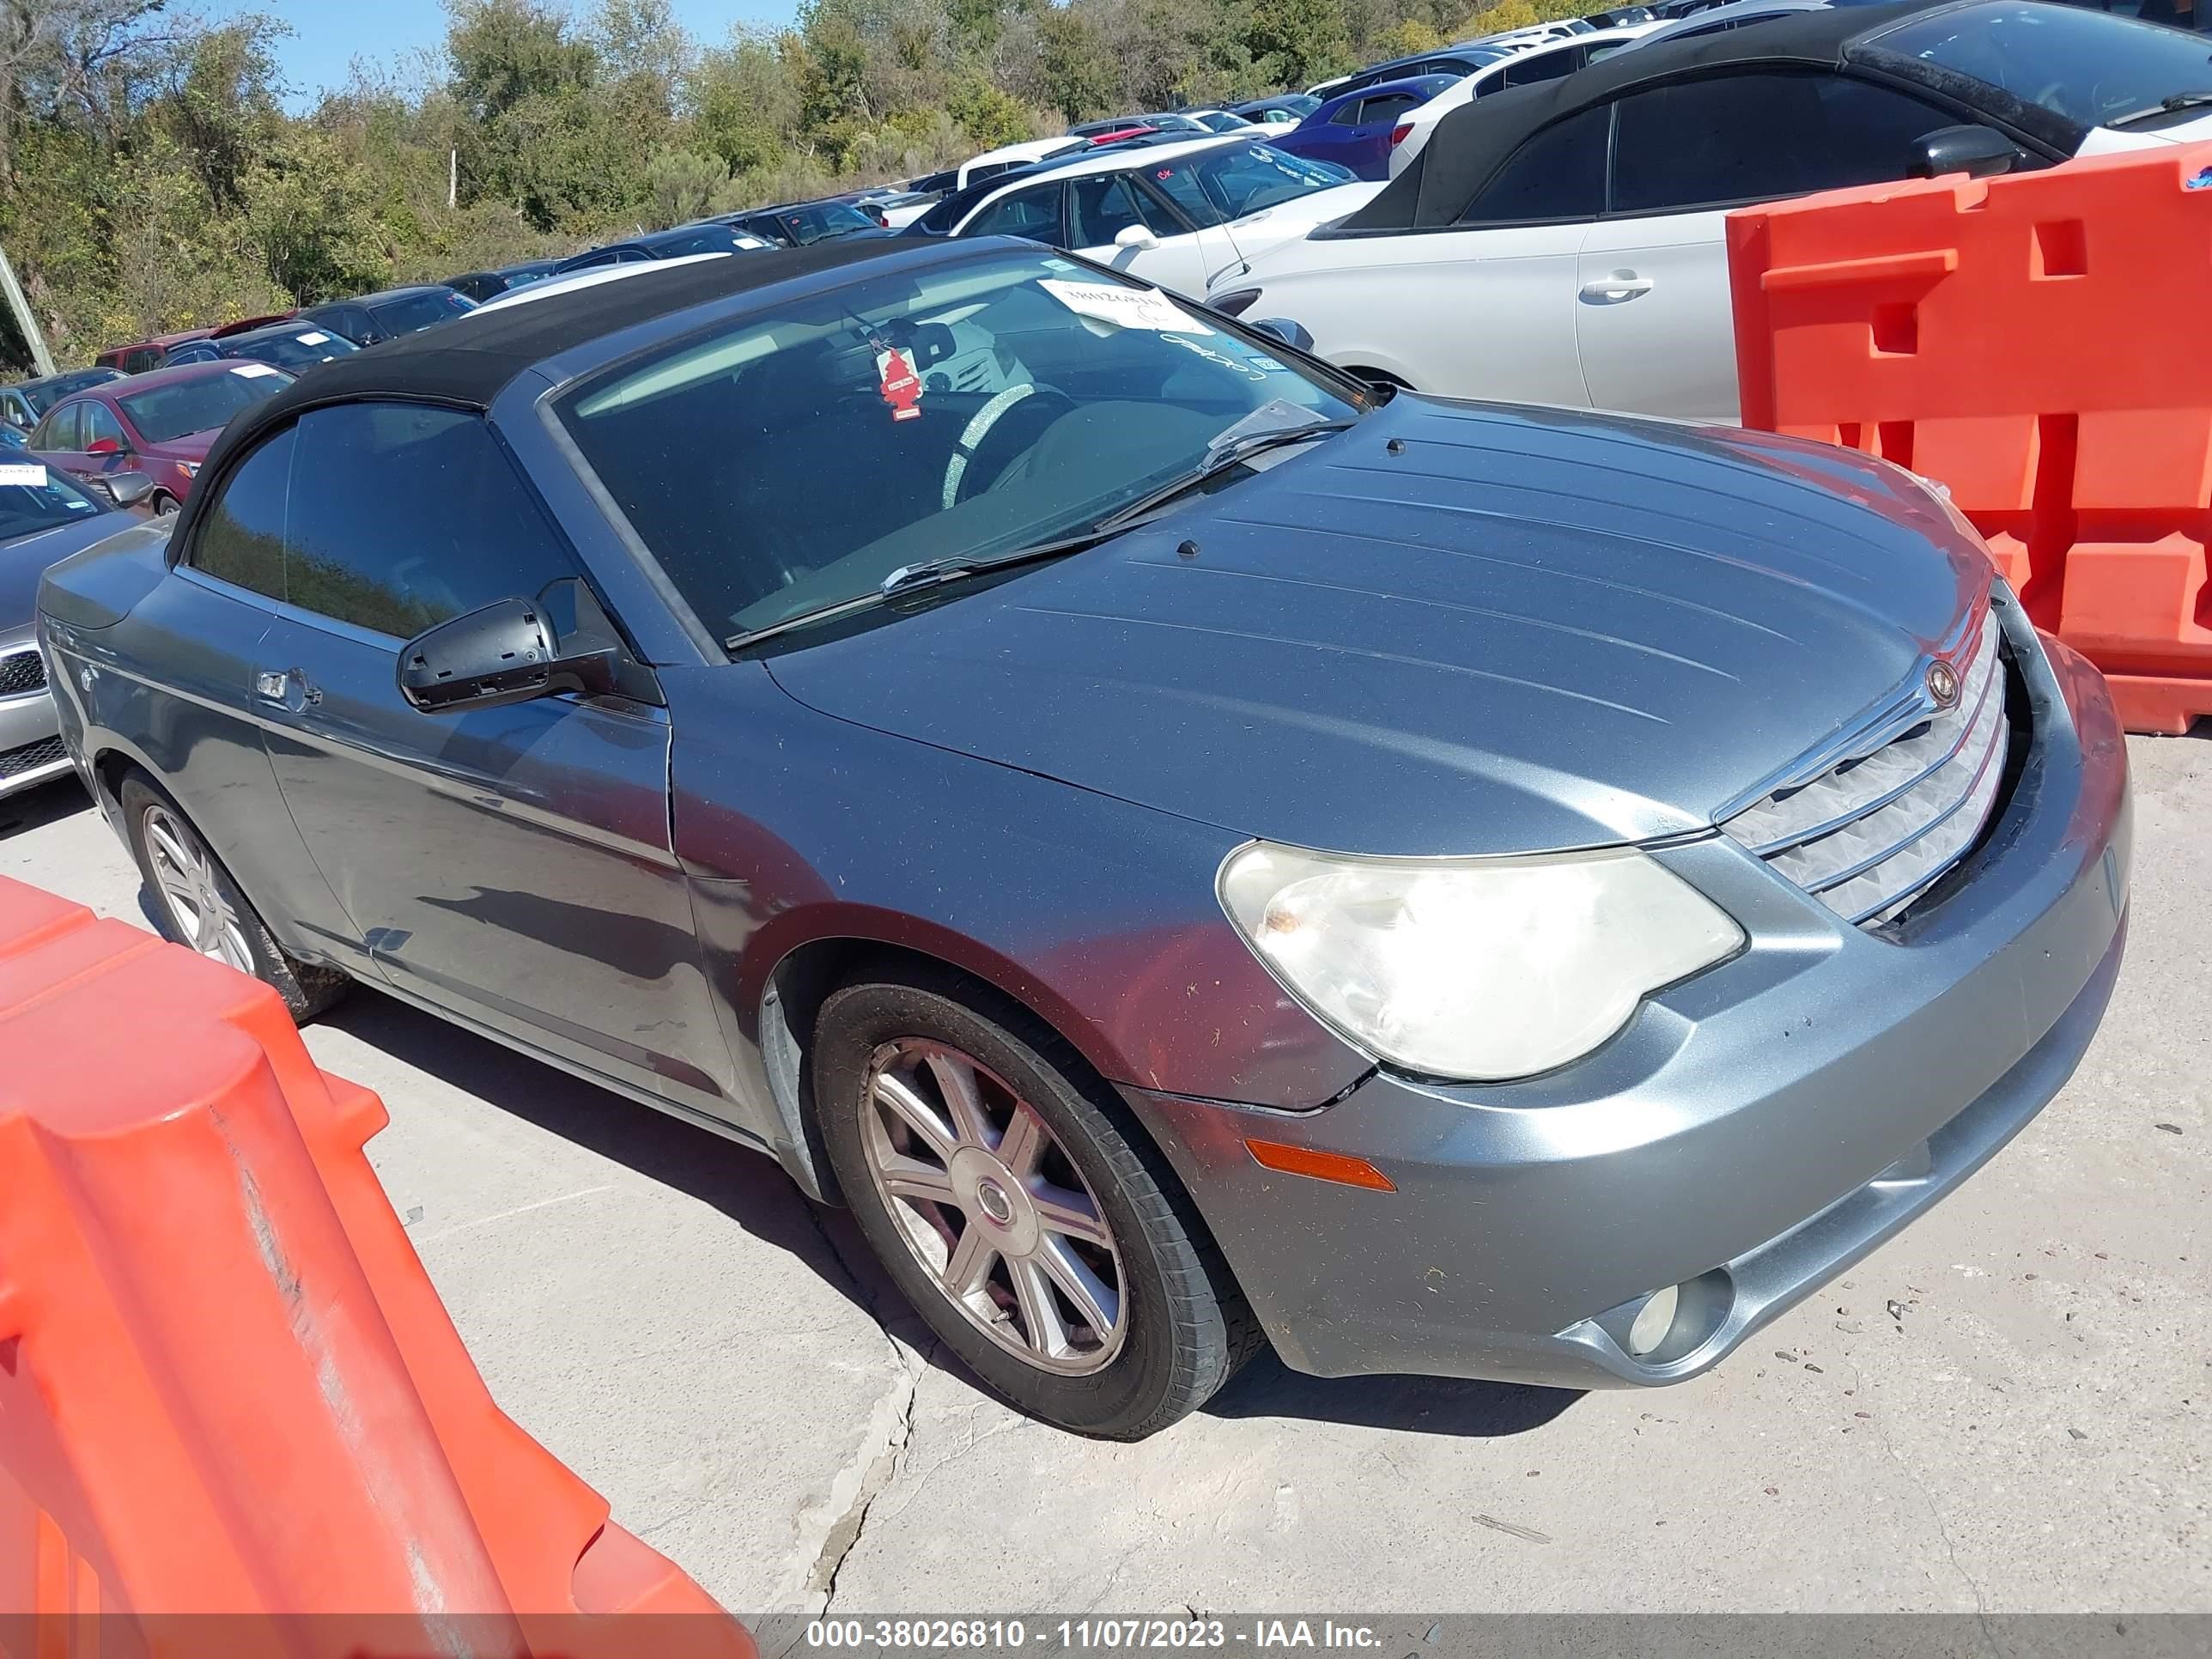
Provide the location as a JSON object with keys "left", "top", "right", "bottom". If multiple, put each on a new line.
{"left": 1124, "top": 608, "right": 2130, "bottom": 1387}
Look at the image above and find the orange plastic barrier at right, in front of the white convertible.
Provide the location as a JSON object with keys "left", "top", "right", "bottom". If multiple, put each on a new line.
{"left": 1728, "top": 143, "right": 2212, "bottom": 732}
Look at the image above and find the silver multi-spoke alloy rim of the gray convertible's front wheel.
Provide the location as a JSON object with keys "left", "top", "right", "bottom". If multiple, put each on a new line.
{"left": 860, "top": 1037, "right": 1128, "bottom": 1376}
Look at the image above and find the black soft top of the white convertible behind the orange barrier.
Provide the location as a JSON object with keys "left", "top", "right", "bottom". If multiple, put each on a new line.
{"left": 1338, "top": 0, "right": 2044, "bottom": 230}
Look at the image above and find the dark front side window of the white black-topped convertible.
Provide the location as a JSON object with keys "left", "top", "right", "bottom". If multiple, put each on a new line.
{"left": 1613, "top": 70, "right": 1958, "bottom": 212}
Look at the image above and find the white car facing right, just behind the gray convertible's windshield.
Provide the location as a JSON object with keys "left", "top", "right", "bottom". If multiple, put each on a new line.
{"left": 947, "top": 137, "right": 1382, "bottom": 299}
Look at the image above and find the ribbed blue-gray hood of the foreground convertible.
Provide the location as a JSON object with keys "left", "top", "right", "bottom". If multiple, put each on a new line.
{"left": 768, "top": 394, "right": 1990, "bottom": 854}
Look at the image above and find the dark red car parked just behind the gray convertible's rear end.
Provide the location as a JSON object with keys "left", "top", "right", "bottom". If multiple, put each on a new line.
{"left": 24, "top": 358, "right": 292, "bottom": 514}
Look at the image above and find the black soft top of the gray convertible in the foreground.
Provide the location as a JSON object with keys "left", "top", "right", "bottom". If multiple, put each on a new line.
{"left": 170, "top": 237, "right": 918, "bottom": 546}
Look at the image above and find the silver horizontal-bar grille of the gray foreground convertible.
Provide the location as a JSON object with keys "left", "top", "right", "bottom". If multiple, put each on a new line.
{"left": 1721, "top": 611, "right": 2008, "bottom": 927}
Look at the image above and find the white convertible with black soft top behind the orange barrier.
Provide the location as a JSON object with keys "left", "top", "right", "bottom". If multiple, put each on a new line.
{"left": 1207, "top": 0, "right": 2212, "bottom": 422}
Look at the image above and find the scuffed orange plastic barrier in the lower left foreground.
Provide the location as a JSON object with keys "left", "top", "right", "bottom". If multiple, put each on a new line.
{"left": 0, "top": 878, "right": 754, "bottom": 1659}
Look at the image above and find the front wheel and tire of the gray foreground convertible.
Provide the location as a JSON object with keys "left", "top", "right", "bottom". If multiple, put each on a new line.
{"left": 814, "top": 975, "right": 1263, "bottom": 1440}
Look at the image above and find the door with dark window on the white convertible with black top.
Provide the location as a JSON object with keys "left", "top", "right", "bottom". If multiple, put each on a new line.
{"left": 1575, "top": 69, "right": 1964, "bottom": 420}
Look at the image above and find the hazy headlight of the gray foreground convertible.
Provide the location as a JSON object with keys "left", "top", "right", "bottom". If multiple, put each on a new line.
{"left": 1218, "top": 841, "right": 1743, "bottom": 1079}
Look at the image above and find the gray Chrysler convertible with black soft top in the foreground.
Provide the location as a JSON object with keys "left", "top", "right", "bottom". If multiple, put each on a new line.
{"left": 40, "top": 241, "right": 2128, "bottom": 1437}
